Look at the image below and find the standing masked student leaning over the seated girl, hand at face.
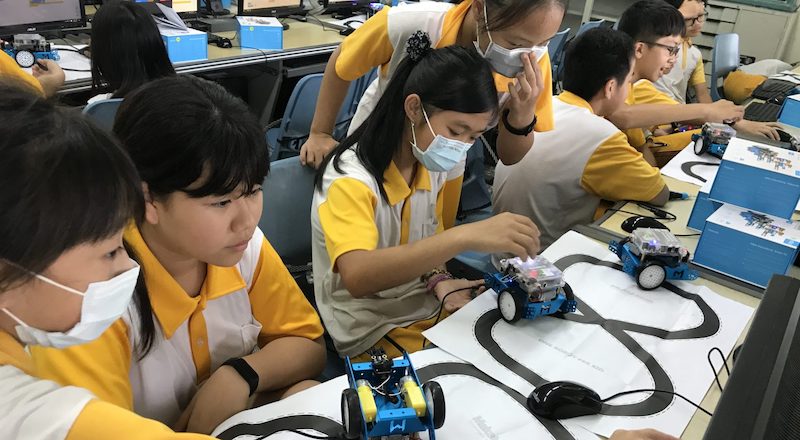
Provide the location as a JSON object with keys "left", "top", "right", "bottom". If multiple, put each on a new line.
{"left": 300, "top": 0, "right": 566, "bottom": 228}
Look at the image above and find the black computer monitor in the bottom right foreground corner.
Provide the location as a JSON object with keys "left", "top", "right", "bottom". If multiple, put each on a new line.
{"left": 704, "top": 275, "right": 800, "bottom": 440}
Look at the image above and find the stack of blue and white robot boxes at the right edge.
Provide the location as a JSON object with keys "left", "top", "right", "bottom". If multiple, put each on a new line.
{"left": 688, "top": 138, "right": 800, "bottom": 287}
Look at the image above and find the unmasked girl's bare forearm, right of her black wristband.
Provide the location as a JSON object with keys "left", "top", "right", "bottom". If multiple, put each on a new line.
{"left": 244, "top": 336, "right": 326, "bottom": 392}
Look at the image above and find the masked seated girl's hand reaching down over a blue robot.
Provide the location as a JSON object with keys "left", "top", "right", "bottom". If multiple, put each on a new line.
{"left": 453, "top": 212, "right": 540, "bottom": 259}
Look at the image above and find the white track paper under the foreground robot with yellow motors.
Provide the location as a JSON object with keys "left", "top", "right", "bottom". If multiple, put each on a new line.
{"left": 213, "top": 348, "right": 597, "bottom": 440}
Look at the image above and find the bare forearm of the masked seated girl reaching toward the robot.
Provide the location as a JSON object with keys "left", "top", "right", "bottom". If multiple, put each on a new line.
{"left": 336, "top": 227, "right": 466, "bottom": 298}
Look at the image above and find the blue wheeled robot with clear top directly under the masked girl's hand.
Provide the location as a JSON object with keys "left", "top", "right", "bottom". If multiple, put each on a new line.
{"left": 485, "top": 256, "right": 577, "bottom": 323}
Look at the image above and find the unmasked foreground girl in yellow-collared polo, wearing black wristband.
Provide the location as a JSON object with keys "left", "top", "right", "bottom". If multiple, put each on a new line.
{"left": 34, "top": 77, "right": 325, "bottom": 433}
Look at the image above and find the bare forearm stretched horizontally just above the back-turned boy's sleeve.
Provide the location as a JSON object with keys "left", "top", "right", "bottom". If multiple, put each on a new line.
{"left": 608, "top": 104, "right": 707, "bottom": 130}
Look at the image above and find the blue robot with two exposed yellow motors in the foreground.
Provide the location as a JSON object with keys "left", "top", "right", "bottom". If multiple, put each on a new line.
{"left": 342, "top": 349, "right": 445, "bottom": 440}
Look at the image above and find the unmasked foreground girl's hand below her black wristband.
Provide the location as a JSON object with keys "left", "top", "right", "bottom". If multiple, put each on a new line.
{"left": 180, "top": 365, "right": 250, "bottom": 434}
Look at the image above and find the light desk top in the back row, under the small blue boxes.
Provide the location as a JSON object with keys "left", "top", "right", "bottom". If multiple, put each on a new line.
{"left": 61, "top": 17, "right": 344, "bottom": 93}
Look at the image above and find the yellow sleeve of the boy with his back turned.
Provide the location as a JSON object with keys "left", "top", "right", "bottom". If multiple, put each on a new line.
{"left": 581, "top": 133, "right": 665, "bottom": 201}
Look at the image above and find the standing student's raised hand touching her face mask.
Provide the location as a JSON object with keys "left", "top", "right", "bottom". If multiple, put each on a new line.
{"left": 505, "top": 52, "right": 544, "bottom": 128}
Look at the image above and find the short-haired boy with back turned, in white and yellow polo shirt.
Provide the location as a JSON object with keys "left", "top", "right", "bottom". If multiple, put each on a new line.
{"left": 493, "top": 29, "right": 669, "bottom": 247}
